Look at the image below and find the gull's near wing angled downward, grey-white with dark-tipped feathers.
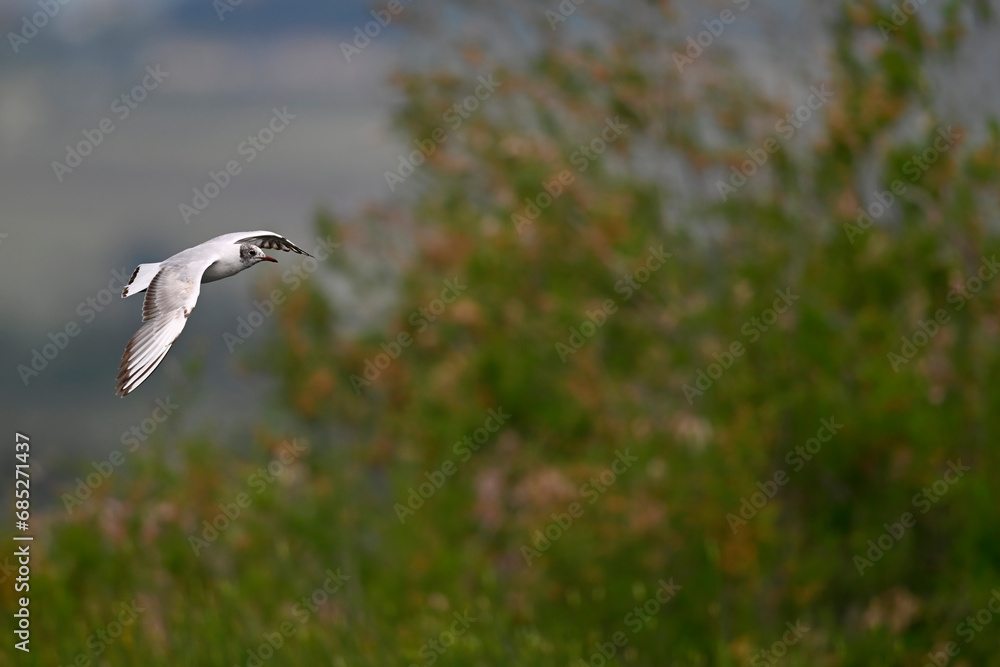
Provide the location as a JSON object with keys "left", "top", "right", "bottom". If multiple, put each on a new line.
{"left": 115, "top": 258, "right": 215, "bottom": 397}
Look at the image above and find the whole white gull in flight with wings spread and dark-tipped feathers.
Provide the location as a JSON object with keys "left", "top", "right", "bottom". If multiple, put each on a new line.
{"left": 116, "top": 231, "right": 309, "bottom": 396}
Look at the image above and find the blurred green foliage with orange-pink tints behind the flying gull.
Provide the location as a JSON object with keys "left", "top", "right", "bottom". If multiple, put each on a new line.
{"left": 0, "top": 1, "right": 1000, "bottom": 666}
